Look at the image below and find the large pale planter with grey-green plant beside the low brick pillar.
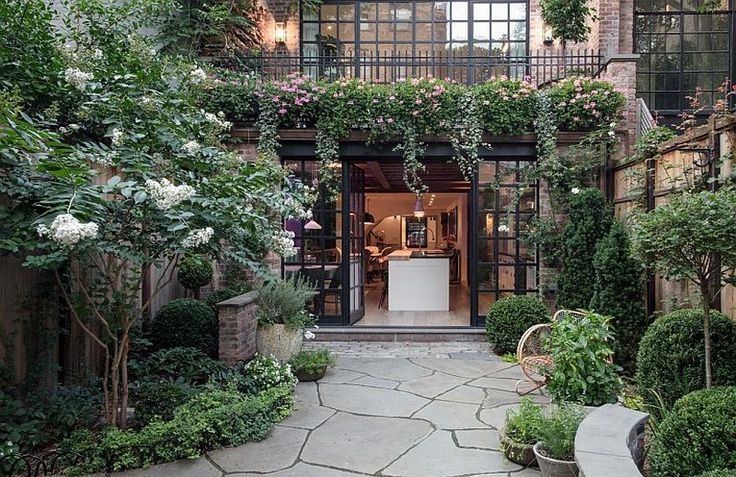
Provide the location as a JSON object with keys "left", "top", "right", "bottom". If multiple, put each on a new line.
{"left": 256, "top": 278, "right": 315, "bottom": 362}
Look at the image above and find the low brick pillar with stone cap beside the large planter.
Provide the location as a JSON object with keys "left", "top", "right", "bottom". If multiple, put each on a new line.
{"left": 217, "top": 291, "right": 258, "bottom": 365}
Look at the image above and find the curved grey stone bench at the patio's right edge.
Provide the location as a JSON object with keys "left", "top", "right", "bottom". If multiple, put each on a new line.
{"left": 575, "top": 404, "right": 649, "bottom": 477}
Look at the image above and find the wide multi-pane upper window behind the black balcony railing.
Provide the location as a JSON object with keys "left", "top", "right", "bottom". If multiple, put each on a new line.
{"left": 302, "top": 0, "right": 528, "bottom": 80}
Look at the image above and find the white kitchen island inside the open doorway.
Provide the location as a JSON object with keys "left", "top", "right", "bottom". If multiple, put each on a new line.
{"left": 386, "top": 249, "right": 452, "bottom": 311}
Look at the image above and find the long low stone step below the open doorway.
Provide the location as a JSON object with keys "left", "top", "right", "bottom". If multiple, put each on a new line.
{"left": 315, "top": 326, "right": 486, "bottom": 343}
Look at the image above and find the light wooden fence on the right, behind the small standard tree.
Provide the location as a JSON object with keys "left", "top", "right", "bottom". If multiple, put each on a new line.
{"left": 613, "top": 114, "right": 736, "bottom": 319}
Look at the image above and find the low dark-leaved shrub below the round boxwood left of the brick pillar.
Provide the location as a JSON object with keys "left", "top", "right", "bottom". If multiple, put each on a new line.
{"left": 133, "top": 348, "right": 228, "bottom": 384}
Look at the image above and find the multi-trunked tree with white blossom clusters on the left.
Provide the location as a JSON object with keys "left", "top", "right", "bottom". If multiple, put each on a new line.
{"left": 0, "top": 0, "right": 313, "bottom": 427}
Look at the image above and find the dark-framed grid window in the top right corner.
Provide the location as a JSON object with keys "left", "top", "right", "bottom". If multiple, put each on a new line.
{"left": 635, "top": 0, "right": 734, "bottom": 116}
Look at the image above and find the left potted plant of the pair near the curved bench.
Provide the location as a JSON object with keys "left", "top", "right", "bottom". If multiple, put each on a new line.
{"left": 500, "top": 397, "right": 544, "bottom": 467}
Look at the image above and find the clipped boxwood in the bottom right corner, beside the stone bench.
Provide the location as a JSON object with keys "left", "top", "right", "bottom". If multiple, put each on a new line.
{"left": 648, "top": 386, "right": 736, "bottom": 477}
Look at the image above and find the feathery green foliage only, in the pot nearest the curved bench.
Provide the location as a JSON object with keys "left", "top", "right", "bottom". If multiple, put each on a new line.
{"left": 539, "top": 403, "right": 585, "bottom": 461}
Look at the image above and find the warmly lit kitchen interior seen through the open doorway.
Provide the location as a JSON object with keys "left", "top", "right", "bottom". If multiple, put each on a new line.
{"left": 355, "top": 191, "right": 470, "bottom": 327}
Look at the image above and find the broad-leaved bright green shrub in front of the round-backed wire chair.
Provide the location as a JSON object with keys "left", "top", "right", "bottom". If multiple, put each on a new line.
{"left": 547, "top": 312, "right": 623, "bottom": 406}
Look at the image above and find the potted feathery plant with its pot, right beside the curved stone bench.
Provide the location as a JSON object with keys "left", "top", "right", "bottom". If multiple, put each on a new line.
{"left": 534, "top": 403, "right": 585, "bottom": 477}
